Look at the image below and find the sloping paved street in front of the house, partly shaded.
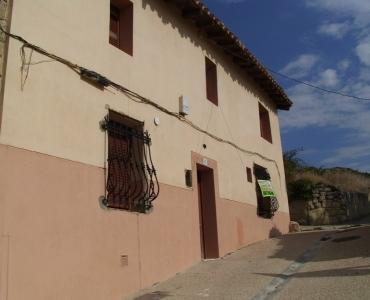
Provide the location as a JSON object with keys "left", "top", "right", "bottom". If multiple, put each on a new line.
{"left": 127, "top": 219, "right": 370, "bottom": 300}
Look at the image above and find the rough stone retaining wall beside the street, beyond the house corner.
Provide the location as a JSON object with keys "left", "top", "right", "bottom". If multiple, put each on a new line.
{"left": 289, "top": 184, "right": 370, "bottom": 225}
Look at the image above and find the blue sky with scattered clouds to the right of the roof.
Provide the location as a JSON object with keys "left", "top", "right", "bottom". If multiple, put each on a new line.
{"left": 204, "top": 0, "right": 370, "bottom": 172}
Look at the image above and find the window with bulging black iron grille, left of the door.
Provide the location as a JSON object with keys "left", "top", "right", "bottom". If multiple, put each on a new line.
{"left": 103, "top": 111, "right": 159, "bottom": 213}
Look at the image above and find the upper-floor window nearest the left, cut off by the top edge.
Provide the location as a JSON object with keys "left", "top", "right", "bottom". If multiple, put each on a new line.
{"left": 109, "top": 0, "right": 133, "bottom": 55}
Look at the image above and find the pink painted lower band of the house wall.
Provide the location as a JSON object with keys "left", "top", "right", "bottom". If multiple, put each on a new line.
{"left": 0, "top": 145, "right": 289, "bottom": 300}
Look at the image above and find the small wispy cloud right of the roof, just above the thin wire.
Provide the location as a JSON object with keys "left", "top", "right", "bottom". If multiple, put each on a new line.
{"left": 281, "top": 54, "right": 319, "bottom": 78}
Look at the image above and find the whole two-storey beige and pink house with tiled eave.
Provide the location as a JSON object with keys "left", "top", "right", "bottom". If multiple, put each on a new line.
{"left": 0, "top": 0, "right": 291, "bottom": 300}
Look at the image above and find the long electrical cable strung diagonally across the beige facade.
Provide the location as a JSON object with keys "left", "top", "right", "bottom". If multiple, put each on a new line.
{"left": 0, "top": 25, "right": 281, "bottom": 175}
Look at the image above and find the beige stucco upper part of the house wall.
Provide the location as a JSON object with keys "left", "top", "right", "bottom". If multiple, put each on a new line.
{"left": 0, "top": 0, "right": 288, "bottom": 212}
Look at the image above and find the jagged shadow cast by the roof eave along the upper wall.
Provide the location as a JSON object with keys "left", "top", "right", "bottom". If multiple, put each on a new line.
{"left": 142, "top": 0, "right": 274, "bottom": 110}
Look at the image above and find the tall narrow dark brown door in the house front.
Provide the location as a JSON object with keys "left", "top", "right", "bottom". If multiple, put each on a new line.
{"left": 197, "top": 165, "right": 219, "bottom": 259}
